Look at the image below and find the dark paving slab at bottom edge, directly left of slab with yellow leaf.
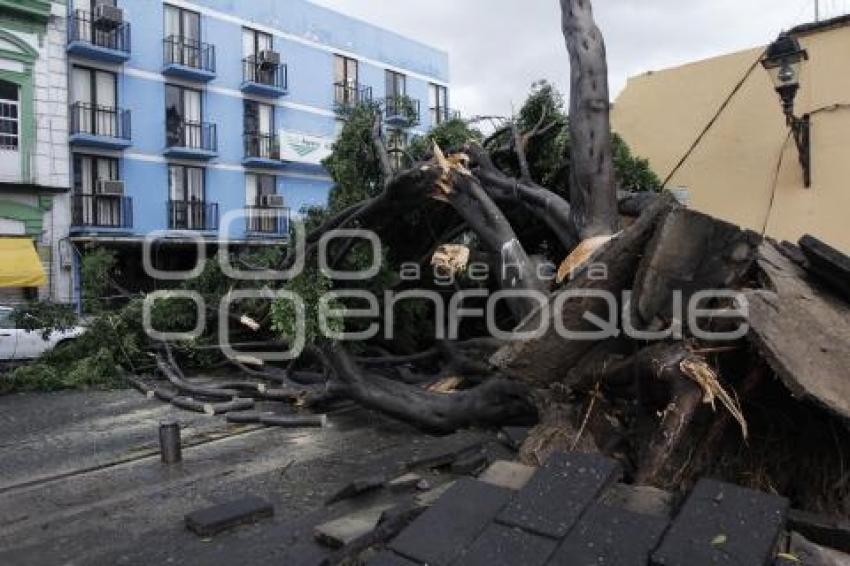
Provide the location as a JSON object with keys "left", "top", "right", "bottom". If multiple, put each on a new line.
{"left": 549, "top": 503, "right": 668, "bottom": 566}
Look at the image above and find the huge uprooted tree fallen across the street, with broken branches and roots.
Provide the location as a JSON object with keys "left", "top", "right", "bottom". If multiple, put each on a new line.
{"left": 13, "top": 0, "right": 850, "bottom": 520}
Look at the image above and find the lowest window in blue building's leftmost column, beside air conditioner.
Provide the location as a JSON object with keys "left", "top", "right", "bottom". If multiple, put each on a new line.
{"left": 72, "top": 155, "right": 122, "bottom": 226}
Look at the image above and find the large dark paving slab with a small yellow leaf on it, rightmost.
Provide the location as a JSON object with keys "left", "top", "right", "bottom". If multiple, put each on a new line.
{"left": 652, "top": 480, "right": 788, "bottom": 566}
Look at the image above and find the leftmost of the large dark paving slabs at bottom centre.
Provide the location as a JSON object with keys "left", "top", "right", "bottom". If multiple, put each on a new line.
{"left": 390, "top": 478, "right": 513, "bottom": 566}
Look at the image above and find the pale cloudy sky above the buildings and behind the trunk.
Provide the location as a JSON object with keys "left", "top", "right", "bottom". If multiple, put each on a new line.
{"left": 313, "top": 0, "right": 850, "bottom": 116}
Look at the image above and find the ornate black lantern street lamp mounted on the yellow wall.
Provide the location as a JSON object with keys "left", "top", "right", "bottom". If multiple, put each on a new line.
{"left": 761, "top": 33, "right": 811, "bottom": 187}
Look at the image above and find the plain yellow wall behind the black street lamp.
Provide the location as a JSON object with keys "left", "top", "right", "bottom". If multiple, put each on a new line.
{"left": 612, "top": 26, "right": 850, "bottom": 253}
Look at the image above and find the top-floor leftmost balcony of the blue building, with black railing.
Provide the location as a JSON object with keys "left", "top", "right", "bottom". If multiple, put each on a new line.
{"left": 67, "top": 10, "right": 130, "bottom": 63}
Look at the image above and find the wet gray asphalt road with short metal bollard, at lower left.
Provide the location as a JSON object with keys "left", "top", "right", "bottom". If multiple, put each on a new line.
{"left": 0, "top": 391, "right": 490, "bottom": 566}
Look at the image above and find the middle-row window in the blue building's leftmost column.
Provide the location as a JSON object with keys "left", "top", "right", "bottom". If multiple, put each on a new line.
{"left": 71, "top": 66, "right": 121, "bottom": 137}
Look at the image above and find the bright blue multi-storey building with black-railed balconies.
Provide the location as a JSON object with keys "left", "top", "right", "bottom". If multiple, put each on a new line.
{"left": 67, "top": 0, "right": 448, "bottom": 288}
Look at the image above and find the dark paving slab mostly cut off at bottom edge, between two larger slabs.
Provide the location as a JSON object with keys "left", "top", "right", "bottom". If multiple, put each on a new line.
{"left": 454, "top": 523, "right": 558, "bottom": 566}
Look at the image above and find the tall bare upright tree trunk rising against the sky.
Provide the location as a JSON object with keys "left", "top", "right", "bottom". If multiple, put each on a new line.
{"left": 561, "top": 0, "right": 620, "bottom": 240}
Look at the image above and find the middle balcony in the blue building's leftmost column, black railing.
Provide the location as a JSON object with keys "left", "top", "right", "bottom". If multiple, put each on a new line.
{"left": 68, "top": 102, "right": 131, "bottom": 149}
